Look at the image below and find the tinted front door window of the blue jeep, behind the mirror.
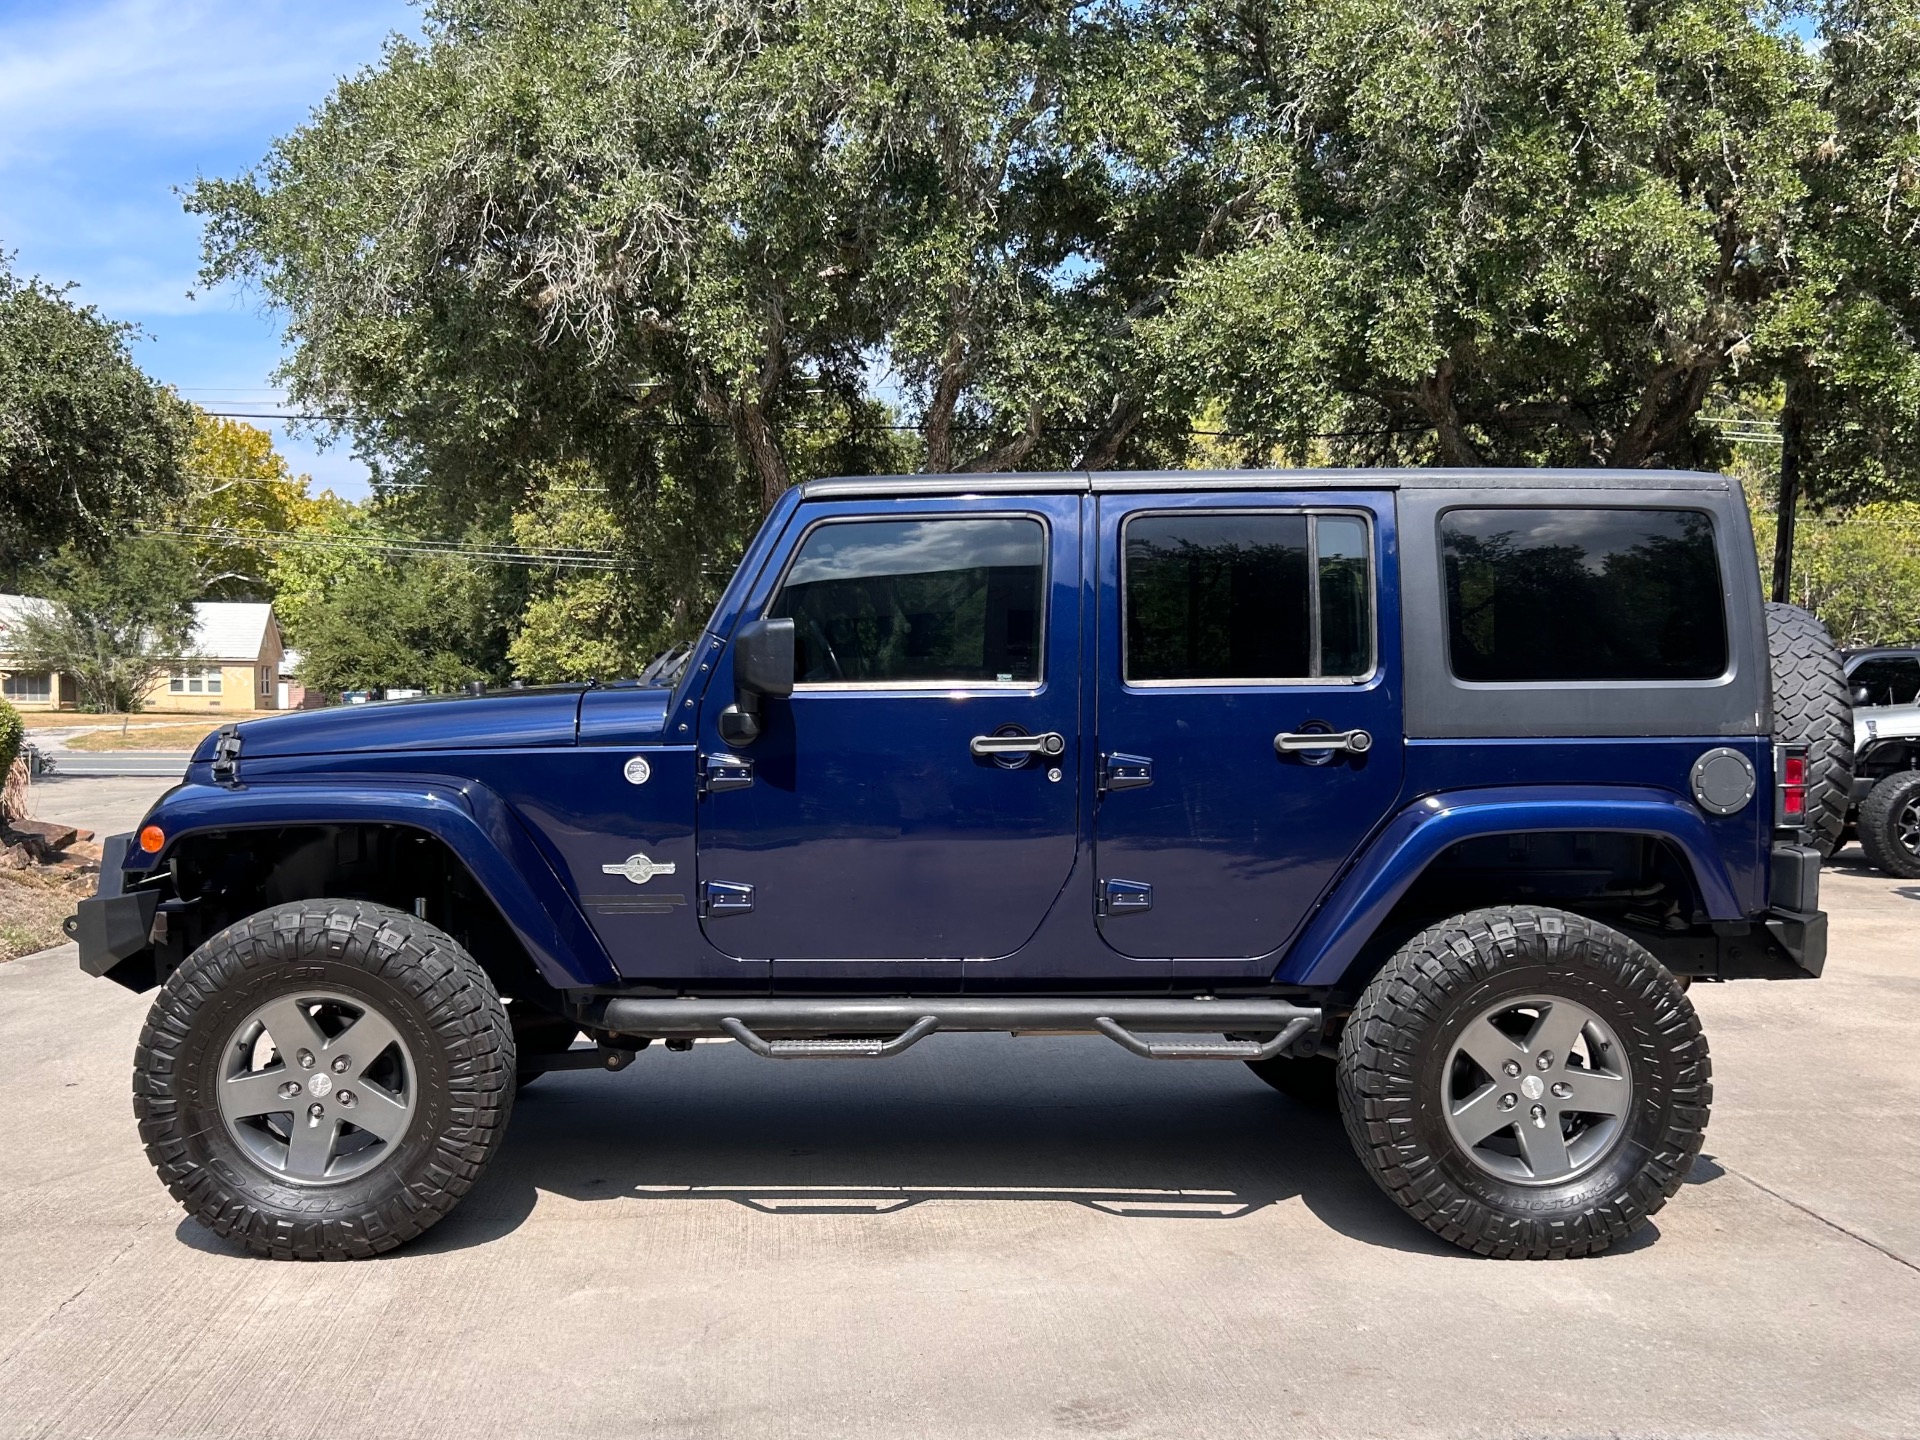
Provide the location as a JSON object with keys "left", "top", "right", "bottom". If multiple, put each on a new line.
{"left": 768, "top": 518, "right": 1046, "bottom": 684}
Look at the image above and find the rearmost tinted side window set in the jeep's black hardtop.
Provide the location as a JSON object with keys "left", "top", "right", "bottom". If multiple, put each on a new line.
{"left": 1440, "top": 509, "right": 1726, "bottom": 682}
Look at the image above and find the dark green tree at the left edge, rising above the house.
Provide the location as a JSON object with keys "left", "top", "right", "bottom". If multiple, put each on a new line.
{"left": 0, "top": 255, "right": 188, "bottom": 586}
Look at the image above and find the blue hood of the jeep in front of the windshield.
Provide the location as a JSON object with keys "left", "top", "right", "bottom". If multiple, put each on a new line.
{"left": 194, "top": 685, "right": 580, "bottom": 760}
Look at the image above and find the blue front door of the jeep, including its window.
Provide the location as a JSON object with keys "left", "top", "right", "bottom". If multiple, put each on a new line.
{"left": 699, "top": 495, "right": 1083, "bottom": 987}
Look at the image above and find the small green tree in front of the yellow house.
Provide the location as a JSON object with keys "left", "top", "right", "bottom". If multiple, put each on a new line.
{"left": 8, "top": 536, "right": 200, "bottom": 712}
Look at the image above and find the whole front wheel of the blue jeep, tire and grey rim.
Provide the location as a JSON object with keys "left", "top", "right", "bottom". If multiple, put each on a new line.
{"left": 132, "top": 900, "right": 515, "bottom": 1260}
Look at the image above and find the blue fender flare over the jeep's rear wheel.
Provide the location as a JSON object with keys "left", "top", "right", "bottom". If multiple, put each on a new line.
{"left": 1273, "top": 785, "right": 1743, "bottom": 985}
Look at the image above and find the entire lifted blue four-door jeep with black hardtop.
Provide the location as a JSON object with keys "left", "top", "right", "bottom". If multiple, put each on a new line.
{"left": 69, "top": 470, "right": 1851, "bottom": 1258}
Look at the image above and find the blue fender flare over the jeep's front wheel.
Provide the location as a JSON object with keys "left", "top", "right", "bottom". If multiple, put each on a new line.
{"left": 129, "top": 774, "right": 618, "bottom": 989}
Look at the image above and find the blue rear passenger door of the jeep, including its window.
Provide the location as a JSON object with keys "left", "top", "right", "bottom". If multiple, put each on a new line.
{"left": 1094, "top": 492, "right": 1402, "bottom": 975}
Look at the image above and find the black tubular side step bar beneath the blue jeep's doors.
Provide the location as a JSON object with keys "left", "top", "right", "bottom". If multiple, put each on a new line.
{"left": 580, "top": 995, "right": 1323, "bottom": 1060}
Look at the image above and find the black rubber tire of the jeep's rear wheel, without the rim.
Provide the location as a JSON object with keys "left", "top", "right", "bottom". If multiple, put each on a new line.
{"left": 1338, "top": 906, "right": 1713, "bottom": 1260}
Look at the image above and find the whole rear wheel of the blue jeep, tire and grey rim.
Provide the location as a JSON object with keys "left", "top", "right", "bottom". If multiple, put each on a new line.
{"left": 1338, "top": 906, "right": 1713, "bottom": 1260}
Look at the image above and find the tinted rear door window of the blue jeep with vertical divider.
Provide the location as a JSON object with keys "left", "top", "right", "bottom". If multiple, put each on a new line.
{"left": 1121, "top": 511, "right": 1373, "bottom": 684}
